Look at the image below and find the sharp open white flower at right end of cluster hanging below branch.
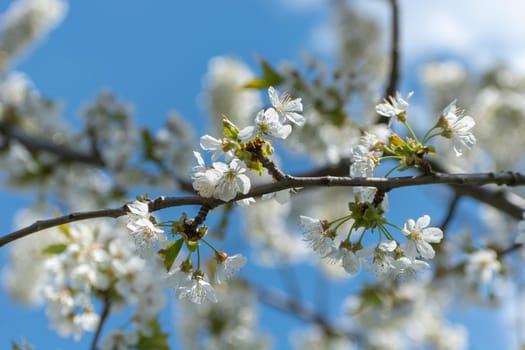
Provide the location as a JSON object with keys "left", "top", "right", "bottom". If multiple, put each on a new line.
{"left": 402, "top": 215, "right": 443, "bottom": 260}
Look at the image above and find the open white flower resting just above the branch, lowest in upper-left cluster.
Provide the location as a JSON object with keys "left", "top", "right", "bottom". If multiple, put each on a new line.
{"left": 213, "top": 159, "right": 251, "bottom": 202}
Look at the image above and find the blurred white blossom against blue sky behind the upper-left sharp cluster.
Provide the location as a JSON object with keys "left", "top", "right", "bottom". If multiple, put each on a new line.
{"left": 200, "top": 56, "right": 262, "bottom": 134}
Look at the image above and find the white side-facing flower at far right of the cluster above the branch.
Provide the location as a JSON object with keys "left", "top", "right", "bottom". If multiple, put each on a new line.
{"left": 440, "top": 100, "right": 476, "bottom": 157}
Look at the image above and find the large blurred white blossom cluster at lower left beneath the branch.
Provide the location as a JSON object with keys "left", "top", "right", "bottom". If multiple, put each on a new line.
{"left": 42, "top": 222, "right": 165, "bottom": 338}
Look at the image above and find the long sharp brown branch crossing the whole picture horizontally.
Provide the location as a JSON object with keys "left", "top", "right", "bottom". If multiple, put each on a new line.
{"left": 0, "top": 172, "right": 525, "bottom": 247}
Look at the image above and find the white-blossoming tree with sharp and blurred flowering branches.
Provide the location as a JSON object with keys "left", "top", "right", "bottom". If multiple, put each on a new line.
{"left": 0, "top": 0, "right": 525, "bottom": 350}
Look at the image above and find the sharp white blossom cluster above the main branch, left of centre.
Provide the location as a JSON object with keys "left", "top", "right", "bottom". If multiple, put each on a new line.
{"left": 192, "top": 87, "right": 305, "bottom": 202}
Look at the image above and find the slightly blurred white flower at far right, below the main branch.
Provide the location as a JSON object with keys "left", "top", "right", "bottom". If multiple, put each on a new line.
{"left": 465, "top": 249, "right": 501, "bottom": 284}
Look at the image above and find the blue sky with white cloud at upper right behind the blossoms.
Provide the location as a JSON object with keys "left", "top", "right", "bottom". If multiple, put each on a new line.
{"left": 0, "top": 0, "right": 525, "bottom": 349}
